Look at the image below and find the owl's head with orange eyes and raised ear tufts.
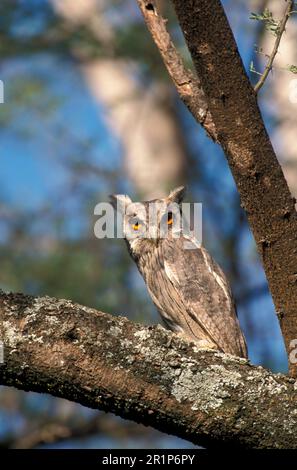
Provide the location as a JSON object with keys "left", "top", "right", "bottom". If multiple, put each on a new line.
{"left": 111, "top": 186, "right": 185, "bottom": 252}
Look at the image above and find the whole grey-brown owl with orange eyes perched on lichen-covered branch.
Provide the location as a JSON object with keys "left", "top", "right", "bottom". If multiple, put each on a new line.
{"left": 111, "top": 187, "right": 247, "bottom": 357}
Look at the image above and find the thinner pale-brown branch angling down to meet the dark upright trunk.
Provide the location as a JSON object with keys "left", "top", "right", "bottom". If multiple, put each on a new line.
{"left": 137, "top": 0, "right": 217, "bottom": 140}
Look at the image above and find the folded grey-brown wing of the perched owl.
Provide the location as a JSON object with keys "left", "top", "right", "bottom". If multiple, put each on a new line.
{"left": 163, "top": 237, "right": 247, "bottom": 357}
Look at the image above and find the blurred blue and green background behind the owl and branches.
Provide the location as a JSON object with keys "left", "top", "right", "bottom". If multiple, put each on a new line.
{"left": 0, "top": 0, "right": 297, "bottom": 448}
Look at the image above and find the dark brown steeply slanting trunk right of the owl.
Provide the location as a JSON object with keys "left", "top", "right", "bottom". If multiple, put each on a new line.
{"left": 138, "top": 0, "right": 297, "bottom": 375}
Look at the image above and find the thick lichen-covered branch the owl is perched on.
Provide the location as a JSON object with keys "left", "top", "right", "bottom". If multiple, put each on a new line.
{"left": 0, "top": 293, "right": 297, "bottom": 448}
